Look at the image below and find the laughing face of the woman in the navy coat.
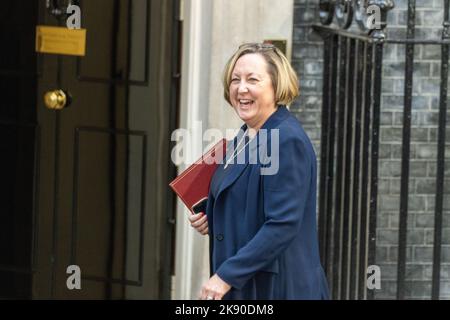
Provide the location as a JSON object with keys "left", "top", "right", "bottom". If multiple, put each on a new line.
{"left": 230, "top": 53, "right": 276, "bottom": 130}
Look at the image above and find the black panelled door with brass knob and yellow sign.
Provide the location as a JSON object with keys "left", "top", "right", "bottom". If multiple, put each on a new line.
{"left": 0, "top": 0, "right": 178, "bottom": 299}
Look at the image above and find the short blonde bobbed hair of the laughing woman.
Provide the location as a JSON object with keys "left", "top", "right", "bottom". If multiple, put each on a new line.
{"left": 222, "top": 43, "right": 300, "bottom": 105}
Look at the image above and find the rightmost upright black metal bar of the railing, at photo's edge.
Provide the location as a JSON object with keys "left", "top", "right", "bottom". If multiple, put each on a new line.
{"left": 431, "top": 0, "right": 450, "bottom": 300}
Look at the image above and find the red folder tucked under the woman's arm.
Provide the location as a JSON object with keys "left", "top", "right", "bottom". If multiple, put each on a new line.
{"left": 169, "top": 139, "right": 226, "bottom": 214}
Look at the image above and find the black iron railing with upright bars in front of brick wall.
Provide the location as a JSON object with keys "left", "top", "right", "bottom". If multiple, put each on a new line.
{"left": 313, "top": 0, "right": 450, "bottom": 299}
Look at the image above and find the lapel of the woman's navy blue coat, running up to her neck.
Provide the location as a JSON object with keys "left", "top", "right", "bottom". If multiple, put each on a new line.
{"left": 216, "top": 105, "right": 290, "bottom": 200}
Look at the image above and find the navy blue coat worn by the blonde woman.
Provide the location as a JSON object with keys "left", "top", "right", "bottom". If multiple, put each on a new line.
{"left": 206, "top": 106, "right": 329, "bottom": 299}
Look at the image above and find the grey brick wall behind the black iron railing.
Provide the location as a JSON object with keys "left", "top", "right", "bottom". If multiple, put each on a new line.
{"left": 291, "top": 0, "right": 450, "bottom": 299}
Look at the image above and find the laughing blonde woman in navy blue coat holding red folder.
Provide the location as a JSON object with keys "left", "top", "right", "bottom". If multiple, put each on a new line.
{"left": 190, "top": 44, "right": 328, "bottom": 300}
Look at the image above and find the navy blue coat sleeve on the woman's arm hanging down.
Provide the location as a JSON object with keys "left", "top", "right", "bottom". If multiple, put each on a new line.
{"left": 216, "top": 136, "right": 313, "bottom": 289}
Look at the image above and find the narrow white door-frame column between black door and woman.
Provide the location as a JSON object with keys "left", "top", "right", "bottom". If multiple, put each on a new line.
{"left": 173, "top": 0, "right": 211, "bottom": 299}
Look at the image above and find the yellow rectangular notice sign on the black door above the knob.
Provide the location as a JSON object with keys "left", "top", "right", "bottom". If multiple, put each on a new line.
{"left": 36, "top": 26, "right": 86, "bottom": 56}
